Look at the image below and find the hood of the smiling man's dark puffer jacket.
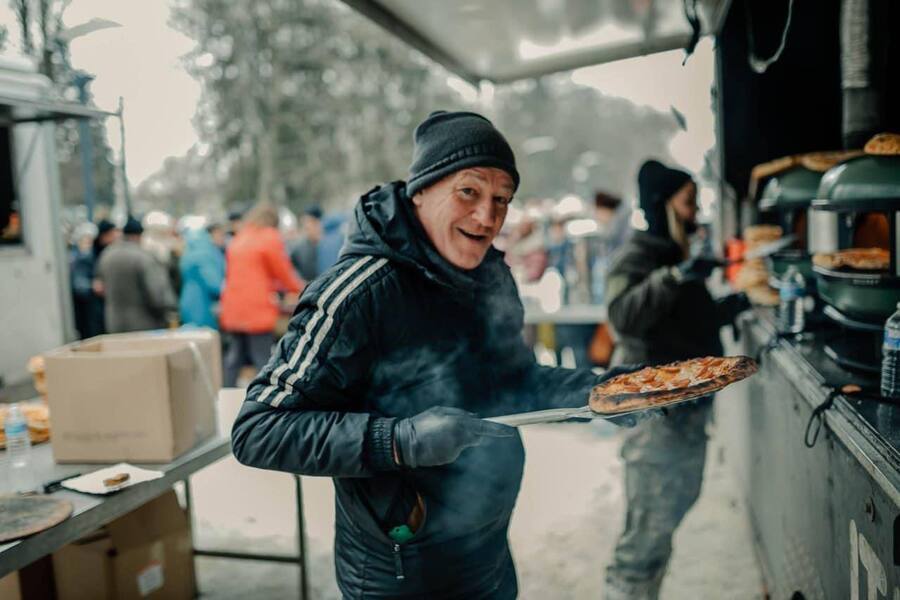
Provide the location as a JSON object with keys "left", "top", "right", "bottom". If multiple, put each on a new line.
{"left": 341, "top": 181, "right": 503, "bottom": 296}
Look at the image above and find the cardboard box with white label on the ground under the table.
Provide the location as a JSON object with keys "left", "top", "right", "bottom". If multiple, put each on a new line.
{"left": 53, "top": 491, "right": 194, "bottom": 600}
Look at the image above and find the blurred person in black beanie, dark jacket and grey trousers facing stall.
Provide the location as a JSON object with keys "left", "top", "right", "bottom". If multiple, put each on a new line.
{"left": 604, "top": 160, "right": 750, "bottom": 600}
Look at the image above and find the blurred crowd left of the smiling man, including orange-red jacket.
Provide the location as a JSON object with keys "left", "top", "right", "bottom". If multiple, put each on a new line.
{"left": 69, "top": 203, "right": 346, "bottom": 386}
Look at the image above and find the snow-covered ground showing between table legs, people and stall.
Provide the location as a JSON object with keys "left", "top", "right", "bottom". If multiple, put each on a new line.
{"left": 193, "top": 398, "right": 763, "bottom": 600}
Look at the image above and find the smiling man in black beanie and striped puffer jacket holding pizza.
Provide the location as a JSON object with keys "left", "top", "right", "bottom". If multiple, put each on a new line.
{"left": 232, "top": 112, "right": 640, "bottom": 598}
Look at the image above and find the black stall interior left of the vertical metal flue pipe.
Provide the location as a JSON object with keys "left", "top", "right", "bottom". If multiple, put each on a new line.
{"left": 716, "top": 0, "right": 841, "bottom": 209}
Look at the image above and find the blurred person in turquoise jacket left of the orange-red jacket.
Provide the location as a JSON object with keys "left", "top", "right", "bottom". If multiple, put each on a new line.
{"left": 178, "top": 224, "right": 225, "bottom": 329}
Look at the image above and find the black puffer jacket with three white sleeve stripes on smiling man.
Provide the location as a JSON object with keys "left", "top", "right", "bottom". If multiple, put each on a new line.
{"left": 232, "top": 182, "right": 597, "bottom": 598}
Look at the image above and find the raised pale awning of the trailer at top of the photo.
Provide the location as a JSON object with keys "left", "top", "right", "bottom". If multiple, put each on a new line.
{"left": 343, "top": 0, "right": 730, "bottom": 83}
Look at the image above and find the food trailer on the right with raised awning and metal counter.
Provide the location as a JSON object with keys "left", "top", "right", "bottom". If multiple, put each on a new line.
{"left": 345, "top": 0, "right": 900, "bottom": 600}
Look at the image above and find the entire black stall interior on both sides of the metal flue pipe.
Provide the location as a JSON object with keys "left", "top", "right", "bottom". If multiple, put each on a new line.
{"left": 716, "top": 0, "right": 900, "bottom": 236}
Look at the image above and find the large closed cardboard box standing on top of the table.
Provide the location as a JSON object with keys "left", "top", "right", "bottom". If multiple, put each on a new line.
{"left": 44, "top": 329, "right": 222, "bottom": 463}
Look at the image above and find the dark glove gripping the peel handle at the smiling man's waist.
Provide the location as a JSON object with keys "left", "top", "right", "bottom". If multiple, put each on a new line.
{"left": 394, "top": 406, "right": 515, "bottom": 469}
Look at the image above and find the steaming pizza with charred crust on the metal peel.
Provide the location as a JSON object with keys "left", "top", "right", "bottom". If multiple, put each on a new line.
{"left": 589, "top": 356, "right": 759, "bottom": 414}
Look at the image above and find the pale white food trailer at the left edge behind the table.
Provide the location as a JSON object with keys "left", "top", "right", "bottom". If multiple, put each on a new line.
{"left": 0, "top": 57, "right": 108, "bottom": 387}
